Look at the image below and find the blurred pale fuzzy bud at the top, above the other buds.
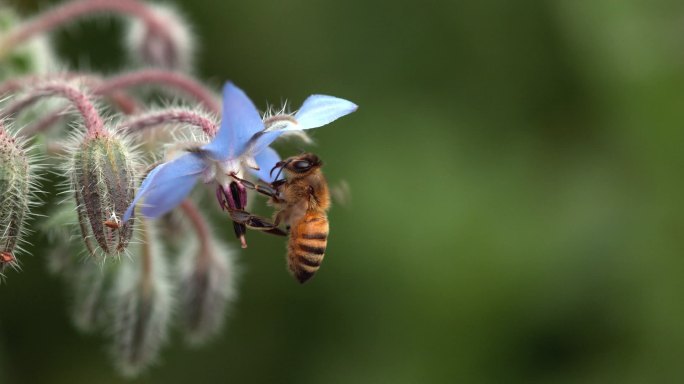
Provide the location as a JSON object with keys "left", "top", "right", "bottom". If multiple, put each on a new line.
{"left": 126, "top": 4, "right": 194, "bottom": 72}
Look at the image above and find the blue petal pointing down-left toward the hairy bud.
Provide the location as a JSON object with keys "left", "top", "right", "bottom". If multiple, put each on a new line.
{"left": 123, "top": 153, "right": 207, "bottom": 222}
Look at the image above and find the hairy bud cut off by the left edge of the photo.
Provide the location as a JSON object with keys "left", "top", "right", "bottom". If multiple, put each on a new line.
{"left": 0, "top": 126, "right": 31, "bottom": 274}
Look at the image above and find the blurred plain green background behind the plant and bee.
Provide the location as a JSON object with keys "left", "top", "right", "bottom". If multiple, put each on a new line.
{"left": 0, "top": 0, "right": 684, "bottom": 384}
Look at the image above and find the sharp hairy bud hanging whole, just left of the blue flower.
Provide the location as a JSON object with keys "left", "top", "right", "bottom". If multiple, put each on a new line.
{"left": 70, "top": 134, "right": 135, "bottom": 255}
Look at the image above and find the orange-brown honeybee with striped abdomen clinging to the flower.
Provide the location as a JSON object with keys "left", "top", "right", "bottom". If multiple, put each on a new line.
{"left": 229, "top": 153, "right": 330, "bottom": 283}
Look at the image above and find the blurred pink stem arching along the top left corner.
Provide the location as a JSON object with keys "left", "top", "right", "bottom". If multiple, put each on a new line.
{"left": 0, "top": 0, "right": 171, "bottom": 56}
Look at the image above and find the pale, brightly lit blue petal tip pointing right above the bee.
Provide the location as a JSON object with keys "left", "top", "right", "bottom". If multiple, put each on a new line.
{"left": 287, "top": 95, "right": 358, "bottom": 130}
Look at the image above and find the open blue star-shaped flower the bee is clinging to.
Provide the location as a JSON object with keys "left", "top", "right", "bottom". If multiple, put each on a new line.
{"left": 123, "top": 82, "right": 357, "bottom": 222}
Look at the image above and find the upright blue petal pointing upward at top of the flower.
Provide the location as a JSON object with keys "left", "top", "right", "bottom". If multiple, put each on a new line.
{"left": 202, "top": 82, "right": 264, "bottom": 161}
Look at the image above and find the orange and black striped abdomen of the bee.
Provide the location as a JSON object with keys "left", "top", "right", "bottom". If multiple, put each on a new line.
{"left": 287, "top": 212, "right": 329, "bottom": 283}
